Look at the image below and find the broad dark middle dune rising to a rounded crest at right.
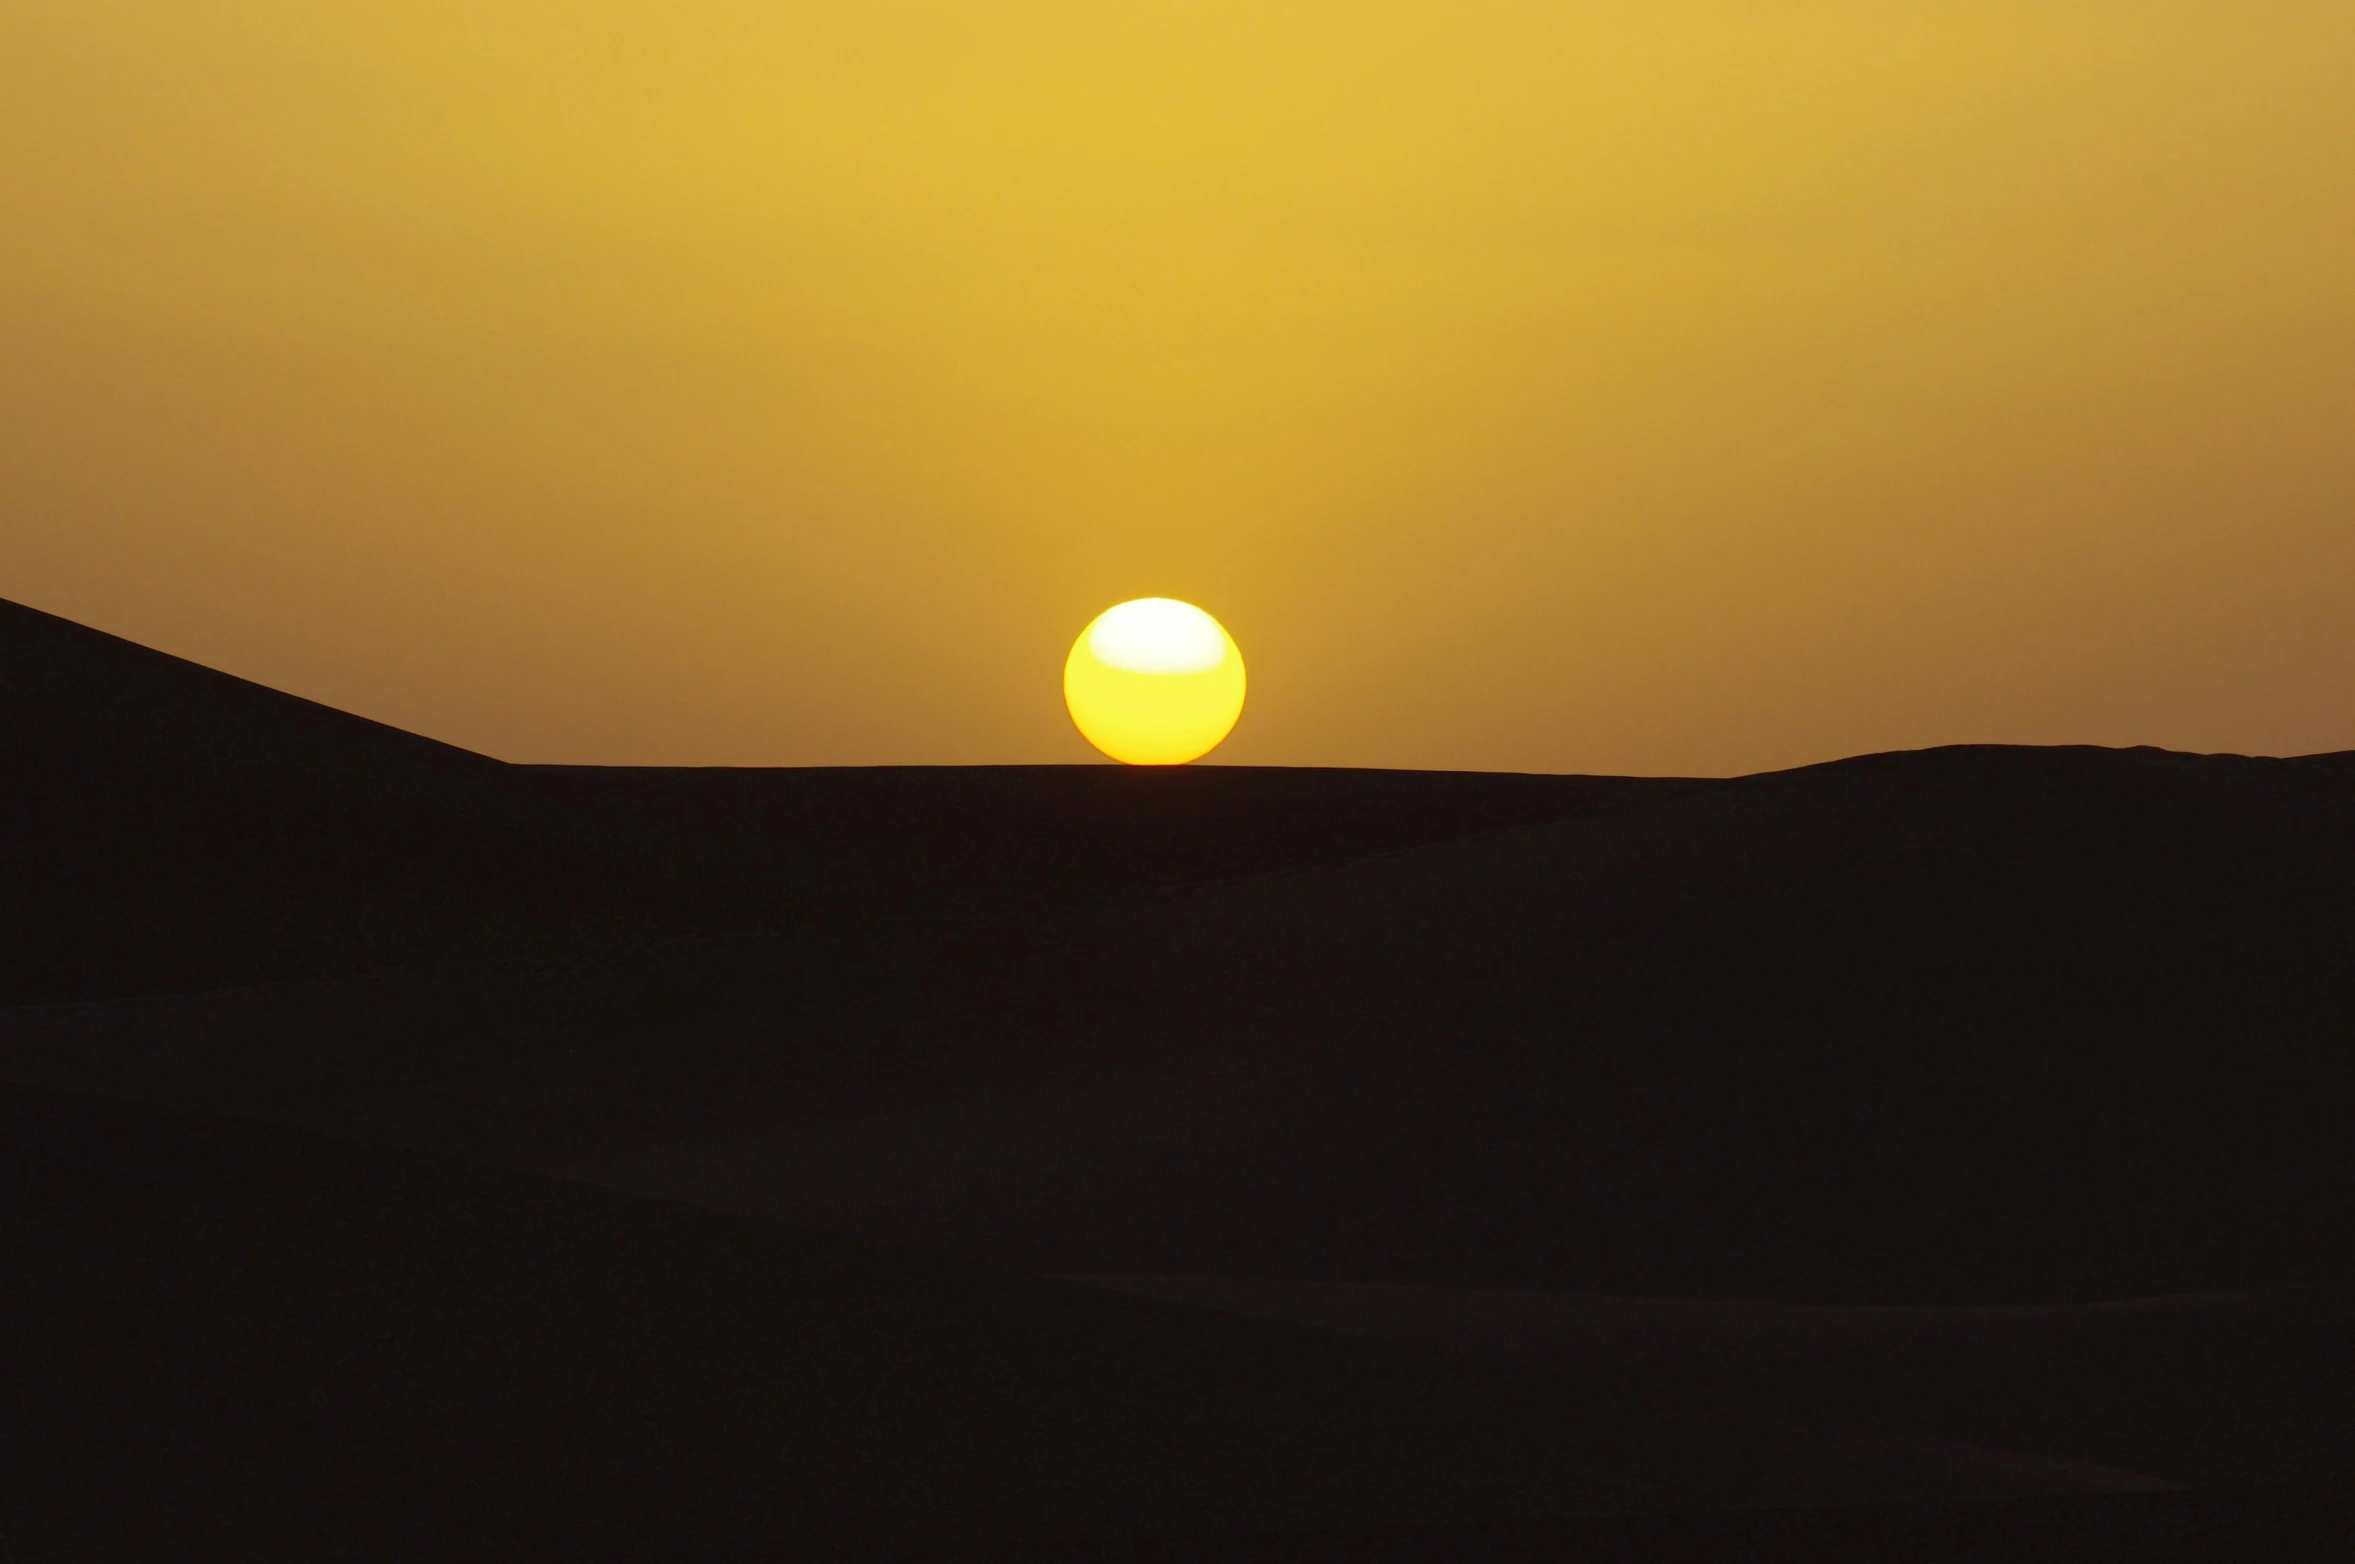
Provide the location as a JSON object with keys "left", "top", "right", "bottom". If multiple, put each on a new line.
{"left": 0, "top": 734, "right": 2355, "bottom": 1303}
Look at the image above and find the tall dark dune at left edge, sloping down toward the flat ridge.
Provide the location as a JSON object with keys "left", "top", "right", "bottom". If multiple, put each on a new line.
{"left": 0, "top": 603, "right": 787, "bottom": 1001}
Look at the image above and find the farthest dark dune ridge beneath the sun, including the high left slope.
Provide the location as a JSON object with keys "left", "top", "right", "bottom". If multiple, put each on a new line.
{"left": 0, "top": 601, "right": 1679, "bottom": 1003}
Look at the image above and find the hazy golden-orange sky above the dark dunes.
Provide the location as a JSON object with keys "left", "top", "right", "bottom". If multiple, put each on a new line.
{"left": 0, "top": 0, "right": 2355, "bottom": 775}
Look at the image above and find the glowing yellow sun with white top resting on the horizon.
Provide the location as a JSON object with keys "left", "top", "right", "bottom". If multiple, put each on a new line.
{"left": 1062, "top": 598, "right": 1243, "bottom": 766}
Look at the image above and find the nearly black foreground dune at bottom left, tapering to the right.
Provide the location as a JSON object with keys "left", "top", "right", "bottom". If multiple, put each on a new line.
{"left": 0, "top": 1088, "right": 2150, "bottom": 1559}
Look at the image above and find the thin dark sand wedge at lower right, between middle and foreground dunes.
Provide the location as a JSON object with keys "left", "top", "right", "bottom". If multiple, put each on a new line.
{"left": 1078, "top": 1277, "right": 2355, "bottom": 1486}
